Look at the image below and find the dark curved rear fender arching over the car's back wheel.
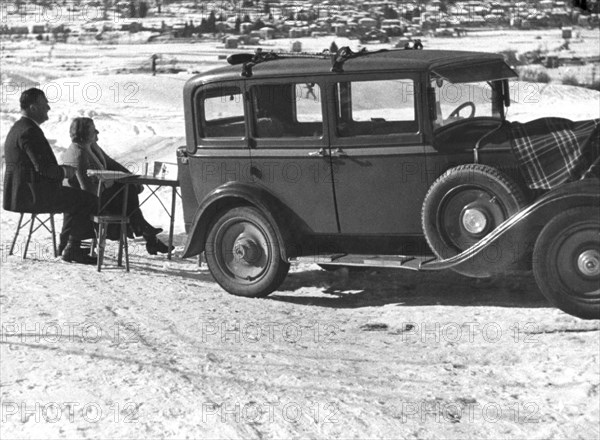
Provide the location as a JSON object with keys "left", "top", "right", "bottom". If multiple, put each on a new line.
{"left": 182, "top": 181, "right": 304, "bottom": 260}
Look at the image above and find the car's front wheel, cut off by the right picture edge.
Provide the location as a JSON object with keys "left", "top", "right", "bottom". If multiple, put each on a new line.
{"left": 533, "top": 206, "right": 600, "bottom": 319}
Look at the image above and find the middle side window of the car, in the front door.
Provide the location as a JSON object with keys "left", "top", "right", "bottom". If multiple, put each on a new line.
{"left": 336, "top": 79, "right": 419, "bottom": 137}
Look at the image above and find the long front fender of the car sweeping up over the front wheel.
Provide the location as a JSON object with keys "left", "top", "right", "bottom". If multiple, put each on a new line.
{"left": 421, "top": 179, "right": 600, "bottom": 276}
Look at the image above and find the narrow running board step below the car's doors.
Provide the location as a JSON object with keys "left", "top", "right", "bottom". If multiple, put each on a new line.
{"left": 290, "top": 254, "right": 436, "bottom": 270}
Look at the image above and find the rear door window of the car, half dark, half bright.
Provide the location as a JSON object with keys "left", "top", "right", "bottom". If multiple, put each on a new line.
{"left": 250, "top": 83, "right": 323, "bottom": 138}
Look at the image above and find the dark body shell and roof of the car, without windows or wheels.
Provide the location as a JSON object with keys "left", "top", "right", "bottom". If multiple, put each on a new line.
{"left": 184, "top": 51, "right": 516, "bottom": 257}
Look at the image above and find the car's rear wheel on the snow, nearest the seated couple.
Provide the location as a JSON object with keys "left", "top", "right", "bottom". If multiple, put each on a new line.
{"left": 206, "top": 206, "right": 290, "bottom": 297}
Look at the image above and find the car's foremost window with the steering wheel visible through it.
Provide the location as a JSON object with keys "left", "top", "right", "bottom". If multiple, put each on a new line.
{"left": 431, "top": 78, "right": 502, "bottom": 128}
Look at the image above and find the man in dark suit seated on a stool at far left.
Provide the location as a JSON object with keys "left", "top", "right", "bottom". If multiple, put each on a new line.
{"left": 3, "top": 88, "right": 98, "bottom": 264}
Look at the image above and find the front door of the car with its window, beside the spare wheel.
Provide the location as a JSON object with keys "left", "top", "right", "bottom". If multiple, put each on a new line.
{"left": 329, "top": 74, "right": 428, "bottom": 236}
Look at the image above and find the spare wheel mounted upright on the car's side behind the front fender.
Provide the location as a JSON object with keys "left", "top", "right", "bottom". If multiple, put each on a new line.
{"left": 421, "top": 164, "right": 525, "bottom": 277}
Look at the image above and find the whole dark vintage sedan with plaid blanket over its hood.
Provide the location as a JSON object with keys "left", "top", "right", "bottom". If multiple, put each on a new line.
{"left": 178, "top": 48, "right": 600, "bottom": 319}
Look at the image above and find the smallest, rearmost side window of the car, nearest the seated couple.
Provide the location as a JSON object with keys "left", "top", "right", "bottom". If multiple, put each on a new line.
{"left": 199, "top": 87, "right": 246, "bottom": 138}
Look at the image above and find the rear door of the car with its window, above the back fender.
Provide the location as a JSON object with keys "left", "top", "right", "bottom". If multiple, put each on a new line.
{"left": 247, "top": 78, "right": 338, "bottom": 234}
